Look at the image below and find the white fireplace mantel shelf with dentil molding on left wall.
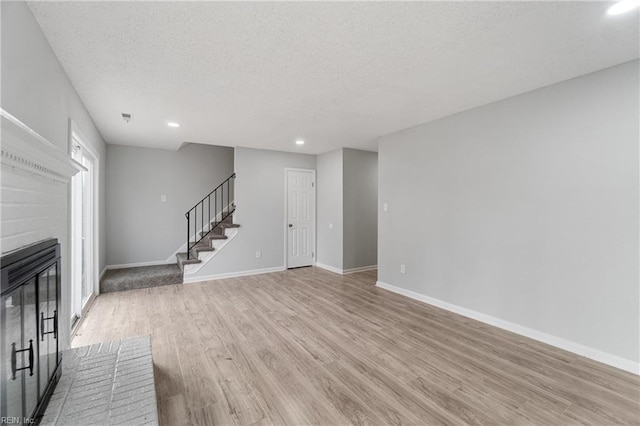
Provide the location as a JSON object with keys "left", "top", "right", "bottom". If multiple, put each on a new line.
{"left": 0, "top": 108, "right": 86, "bottom": 183}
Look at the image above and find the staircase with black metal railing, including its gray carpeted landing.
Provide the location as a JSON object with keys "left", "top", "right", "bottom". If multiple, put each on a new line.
{"left": 100, "top": 173, "right": 240, "bottom": 293}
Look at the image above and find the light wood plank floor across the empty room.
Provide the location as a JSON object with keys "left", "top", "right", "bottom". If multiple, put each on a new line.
{"left": 73, "top": 268, "right": 640, "bottom": 426}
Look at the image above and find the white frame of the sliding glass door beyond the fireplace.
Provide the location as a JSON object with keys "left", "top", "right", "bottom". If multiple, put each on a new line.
{"left": 69, "top": 119, "right": 101, "bottom": 328}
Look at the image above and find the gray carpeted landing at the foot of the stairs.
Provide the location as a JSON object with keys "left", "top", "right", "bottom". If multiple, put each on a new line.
{"left": 100, "top": 263, "right": 182, "bottom": 293}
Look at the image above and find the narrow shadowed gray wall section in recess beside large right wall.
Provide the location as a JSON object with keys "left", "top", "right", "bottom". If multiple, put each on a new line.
{"left": 342, "top": 148, "right": 378, "bottom": 270}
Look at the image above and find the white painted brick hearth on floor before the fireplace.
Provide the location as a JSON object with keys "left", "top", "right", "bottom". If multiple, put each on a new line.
{"left": 41, "top": 336, "right": 158, "bottom": 426}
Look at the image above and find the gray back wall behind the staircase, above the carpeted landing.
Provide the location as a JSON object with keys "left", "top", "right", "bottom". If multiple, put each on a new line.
{"left": 107, "top": 144, "right": 233, "bottom": 265}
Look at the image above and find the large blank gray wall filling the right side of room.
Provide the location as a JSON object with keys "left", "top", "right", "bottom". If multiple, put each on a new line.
{"left": 379, "top": 61, "right": 640, "bottom": 362}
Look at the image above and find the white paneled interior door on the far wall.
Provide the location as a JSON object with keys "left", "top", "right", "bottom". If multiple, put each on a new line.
{"left": 286, "top": 169, "right": 316, "bottom": 268}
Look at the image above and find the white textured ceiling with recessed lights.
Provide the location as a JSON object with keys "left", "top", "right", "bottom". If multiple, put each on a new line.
{"left": 30, "top": 1, "right": 639, "bottom": 153}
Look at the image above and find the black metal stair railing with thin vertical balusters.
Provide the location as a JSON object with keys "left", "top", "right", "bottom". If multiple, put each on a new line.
{"left": 184, "top": 173, "right": 236, "bottom": 260}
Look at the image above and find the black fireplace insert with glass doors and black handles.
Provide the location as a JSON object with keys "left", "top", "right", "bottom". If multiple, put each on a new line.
{"left": 0, "top": 239, "right": 62, "bottom": 424}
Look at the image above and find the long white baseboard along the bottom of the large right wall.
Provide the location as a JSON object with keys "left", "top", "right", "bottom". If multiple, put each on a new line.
{"left": 376, "top": 281, "right": 640, "bottom": 375}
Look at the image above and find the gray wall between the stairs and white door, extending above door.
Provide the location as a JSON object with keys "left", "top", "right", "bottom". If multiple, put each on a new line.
{"left": 195, "top": 148, "right": 316, "bottom": 277}
